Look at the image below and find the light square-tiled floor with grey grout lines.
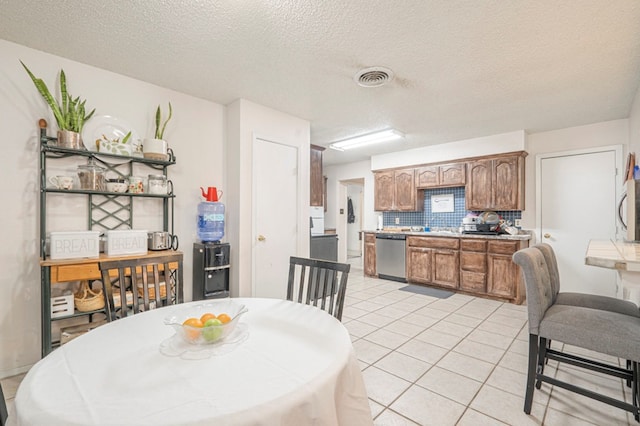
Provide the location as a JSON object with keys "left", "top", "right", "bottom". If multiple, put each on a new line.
{"left": 2, "top": 258, "right": 638, "bottom": 426}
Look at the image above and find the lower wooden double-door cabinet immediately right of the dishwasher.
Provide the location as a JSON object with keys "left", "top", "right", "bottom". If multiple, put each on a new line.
{"left": 407, "top": 237, "right": 460, "bottom": 288}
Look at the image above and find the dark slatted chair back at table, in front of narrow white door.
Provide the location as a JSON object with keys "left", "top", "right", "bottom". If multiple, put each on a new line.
{"left": 287, "top": 256, "right": 351, "bottom": 321}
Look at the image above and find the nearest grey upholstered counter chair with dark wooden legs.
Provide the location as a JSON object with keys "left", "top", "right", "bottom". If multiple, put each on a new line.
{"left": 513, "top": 247, "right": 640, "bottom": 421}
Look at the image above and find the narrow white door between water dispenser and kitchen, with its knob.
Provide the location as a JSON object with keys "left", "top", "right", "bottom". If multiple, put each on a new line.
{"left": 252, "top": 138, "right": 298, "bottom": 299}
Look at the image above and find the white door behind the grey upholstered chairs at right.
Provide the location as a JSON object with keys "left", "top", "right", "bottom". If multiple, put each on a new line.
{"left": 536, "top": 147, "right": 622, "bottom": 297}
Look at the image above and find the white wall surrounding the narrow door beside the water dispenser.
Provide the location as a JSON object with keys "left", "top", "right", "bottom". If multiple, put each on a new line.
{"left": 226, "top": 99, "right": 311, "bottom": 296}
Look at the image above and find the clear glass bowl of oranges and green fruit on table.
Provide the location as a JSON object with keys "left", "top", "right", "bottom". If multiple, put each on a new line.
{"left": 164, "top": 299, "right": 247, "bottom": 345}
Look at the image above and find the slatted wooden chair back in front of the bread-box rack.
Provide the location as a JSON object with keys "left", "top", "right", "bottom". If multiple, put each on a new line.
{"left": 100, "top": 253, "right": 184, "bottom": 321}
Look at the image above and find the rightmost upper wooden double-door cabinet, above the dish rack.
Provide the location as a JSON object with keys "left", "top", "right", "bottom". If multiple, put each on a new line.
{"left": 465, "top": 152, "right": 526, "bottom": 210}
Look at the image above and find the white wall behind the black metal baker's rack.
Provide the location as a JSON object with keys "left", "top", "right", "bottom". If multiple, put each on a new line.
{"left": 0, "top": 40, "right": 225, "bottom": 377}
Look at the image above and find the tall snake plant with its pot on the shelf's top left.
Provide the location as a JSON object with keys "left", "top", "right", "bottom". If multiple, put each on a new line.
{"left": 20, "top": 61, "right": 96, "bottom": 149}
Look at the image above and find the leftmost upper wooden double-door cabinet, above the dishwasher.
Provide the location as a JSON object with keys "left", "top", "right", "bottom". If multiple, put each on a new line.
{"left": 374, "top": 169, "right": 424, "bottom": 212}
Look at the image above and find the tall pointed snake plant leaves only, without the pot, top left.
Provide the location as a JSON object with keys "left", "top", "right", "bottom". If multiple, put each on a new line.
{"left": 20, "top": 61, "right": 96, "bottom": 133}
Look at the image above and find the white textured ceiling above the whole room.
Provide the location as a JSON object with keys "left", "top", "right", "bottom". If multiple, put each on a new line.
{"left": 0, "top": 0, "right": 640, "bottom": 164}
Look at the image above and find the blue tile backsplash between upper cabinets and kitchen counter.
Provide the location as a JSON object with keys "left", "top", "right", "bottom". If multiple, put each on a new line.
{"left": 382, "top": 186, "right": 522, "bottom": 228}
